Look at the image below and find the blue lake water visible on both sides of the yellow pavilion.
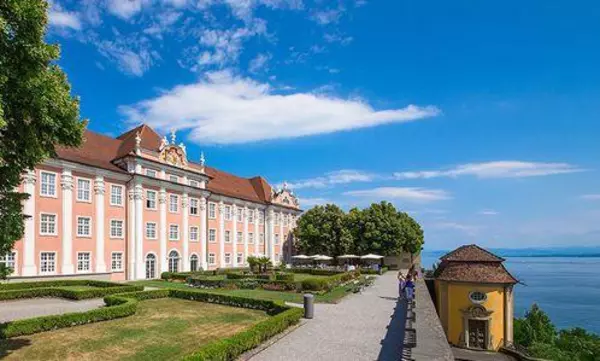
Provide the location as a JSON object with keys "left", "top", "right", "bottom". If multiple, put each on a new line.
{"left": 422, "top": 254, "right": 600, "bottom": 334}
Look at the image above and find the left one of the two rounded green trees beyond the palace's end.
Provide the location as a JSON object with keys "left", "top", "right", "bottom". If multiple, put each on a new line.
{"left": 294, "top": 204, "right": 353, "bottom": 257}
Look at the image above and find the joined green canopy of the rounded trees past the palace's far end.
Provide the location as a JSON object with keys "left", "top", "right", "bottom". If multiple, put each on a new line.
{"left": 295, "top": 202, "right": 423, "bottom": 257}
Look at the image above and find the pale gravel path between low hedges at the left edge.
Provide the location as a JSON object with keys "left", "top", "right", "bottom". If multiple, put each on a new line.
{"left": 0, "top": 298, "right": 104, "bottom": 323}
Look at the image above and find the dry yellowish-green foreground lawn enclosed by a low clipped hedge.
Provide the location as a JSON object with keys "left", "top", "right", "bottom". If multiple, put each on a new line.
{"left": 0, "top": 298, "right": 268, "bottom": 361}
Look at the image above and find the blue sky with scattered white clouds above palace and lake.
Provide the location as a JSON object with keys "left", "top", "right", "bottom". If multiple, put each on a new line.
{"left": 47, "top": 0, "right": 600, "bottom": 250}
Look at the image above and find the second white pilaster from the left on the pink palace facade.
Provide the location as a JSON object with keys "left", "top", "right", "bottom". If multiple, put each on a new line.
{"left": 60, "top": 168, "right": 75, "bottom": 275}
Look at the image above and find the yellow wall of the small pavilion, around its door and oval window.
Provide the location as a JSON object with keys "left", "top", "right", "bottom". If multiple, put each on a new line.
{"left": 446, "top": 282, "right": 504, "bottom": 350}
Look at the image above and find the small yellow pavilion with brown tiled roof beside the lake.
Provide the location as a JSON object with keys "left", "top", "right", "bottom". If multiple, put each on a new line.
{"left": 435, "top": 244, "right": 518, "bottom": 350}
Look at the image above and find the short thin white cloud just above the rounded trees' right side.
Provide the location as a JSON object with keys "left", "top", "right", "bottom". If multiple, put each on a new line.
{"left": 344, "top": 187, "right": 451, "bottom": 203}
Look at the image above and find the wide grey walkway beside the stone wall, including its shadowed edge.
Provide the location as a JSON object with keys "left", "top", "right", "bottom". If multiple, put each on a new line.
{"left": 252, "top": 272, "right": 406, "bottom": 361}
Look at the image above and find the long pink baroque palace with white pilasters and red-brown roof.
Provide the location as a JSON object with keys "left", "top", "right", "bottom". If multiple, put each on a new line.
{"left": 5, "top": 125, "right": 301, "bottom": 280}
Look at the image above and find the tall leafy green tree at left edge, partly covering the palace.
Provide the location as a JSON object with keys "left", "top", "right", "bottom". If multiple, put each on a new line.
{"left": 0, "top": 0, "right": 84, "bottom": 254}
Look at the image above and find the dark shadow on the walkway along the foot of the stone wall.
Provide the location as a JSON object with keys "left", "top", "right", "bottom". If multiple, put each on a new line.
{"left": 377, "top": 296, "right": 408, "bottom": 361}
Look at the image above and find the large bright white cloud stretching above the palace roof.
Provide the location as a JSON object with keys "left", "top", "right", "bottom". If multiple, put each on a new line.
{"left": 120, "top": 71, "right": 440, "bottom": 144}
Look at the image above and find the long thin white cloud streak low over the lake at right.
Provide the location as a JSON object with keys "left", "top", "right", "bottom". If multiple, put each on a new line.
{"left": 394, "top": 160, "right": 584, "bottom": 179}
